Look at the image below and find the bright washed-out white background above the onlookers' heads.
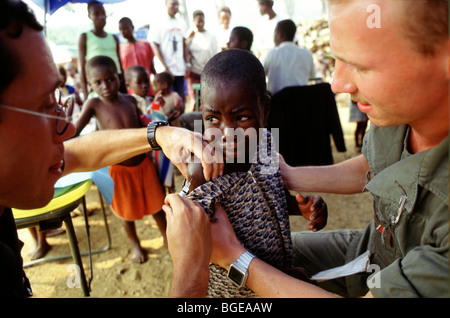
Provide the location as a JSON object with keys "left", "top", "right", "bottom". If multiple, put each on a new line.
{"left": 24, "top": 0, "right": 326, "bottom": 61}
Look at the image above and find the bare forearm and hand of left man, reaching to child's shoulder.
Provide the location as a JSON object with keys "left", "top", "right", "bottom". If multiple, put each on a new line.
{"left": 64, "top": 126, "right": 223, "bottom": 180}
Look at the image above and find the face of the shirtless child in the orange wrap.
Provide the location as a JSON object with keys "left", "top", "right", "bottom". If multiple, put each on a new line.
{"left": 87, "top": 65, "right": 120, "bottom": 100}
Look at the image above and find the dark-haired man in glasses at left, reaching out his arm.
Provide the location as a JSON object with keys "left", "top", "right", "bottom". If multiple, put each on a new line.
{"left": 0, "top": 0, "right": 220, "bottom": 297}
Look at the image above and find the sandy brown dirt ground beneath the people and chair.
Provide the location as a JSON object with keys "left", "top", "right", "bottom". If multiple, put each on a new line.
{"left": 19, "top": 95, "right": 372, "bottom": 298}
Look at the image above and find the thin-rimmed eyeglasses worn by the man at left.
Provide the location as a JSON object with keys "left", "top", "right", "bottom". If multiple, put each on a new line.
{"left": 0, "top": 89, "right": 75, "bottom": 135}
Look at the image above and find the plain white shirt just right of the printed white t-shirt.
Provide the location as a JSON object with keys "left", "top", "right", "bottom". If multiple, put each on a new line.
{"left": 187, "top": 31, "right": 219, "bottom": 74}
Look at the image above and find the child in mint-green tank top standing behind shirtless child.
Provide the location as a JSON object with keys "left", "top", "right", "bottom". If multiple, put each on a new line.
{"left": 78, "top": 1, "right": 126, "bottom": 100}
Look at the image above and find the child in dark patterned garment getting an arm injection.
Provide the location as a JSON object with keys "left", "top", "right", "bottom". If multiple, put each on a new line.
{"left": 184, "top": 49, "right": 327, "bottom": 297}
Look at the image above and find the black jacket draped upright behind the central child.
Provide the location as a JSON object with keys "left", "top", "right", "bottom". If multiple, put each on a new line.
{"left": 267, "top": 83, "right": 346, "bottom": 166}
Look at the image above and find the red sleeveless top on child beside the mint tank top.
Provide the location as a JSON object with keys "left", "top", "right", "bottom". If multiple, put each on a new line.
{"left": 119, "top": 40, "right": 155, "bottom": 96}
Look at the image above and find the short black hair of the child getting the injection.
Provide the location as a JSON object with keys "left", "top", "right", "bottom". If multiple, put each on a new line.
{"left": 201, "top": 49, "right": 267, "bottom": 101}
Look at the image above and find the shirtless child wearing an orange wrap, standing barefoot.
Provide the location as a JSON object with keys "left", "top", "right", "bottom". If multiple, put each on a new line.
{"left": 76, "top": 56, "right": 167, "bottom": 263}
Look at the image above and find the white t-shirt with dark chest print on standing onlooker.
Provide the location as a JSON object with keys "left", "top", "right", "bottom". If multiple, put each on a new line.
{"left": 147, "top": 15, "right": 186, "bottom": 76}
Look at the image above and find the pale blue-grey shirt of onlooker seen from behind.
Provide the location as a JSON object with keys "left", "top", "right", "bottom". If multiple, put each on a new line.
{"left": 264, "top": 42, "right": 316, "bottom": 95}
